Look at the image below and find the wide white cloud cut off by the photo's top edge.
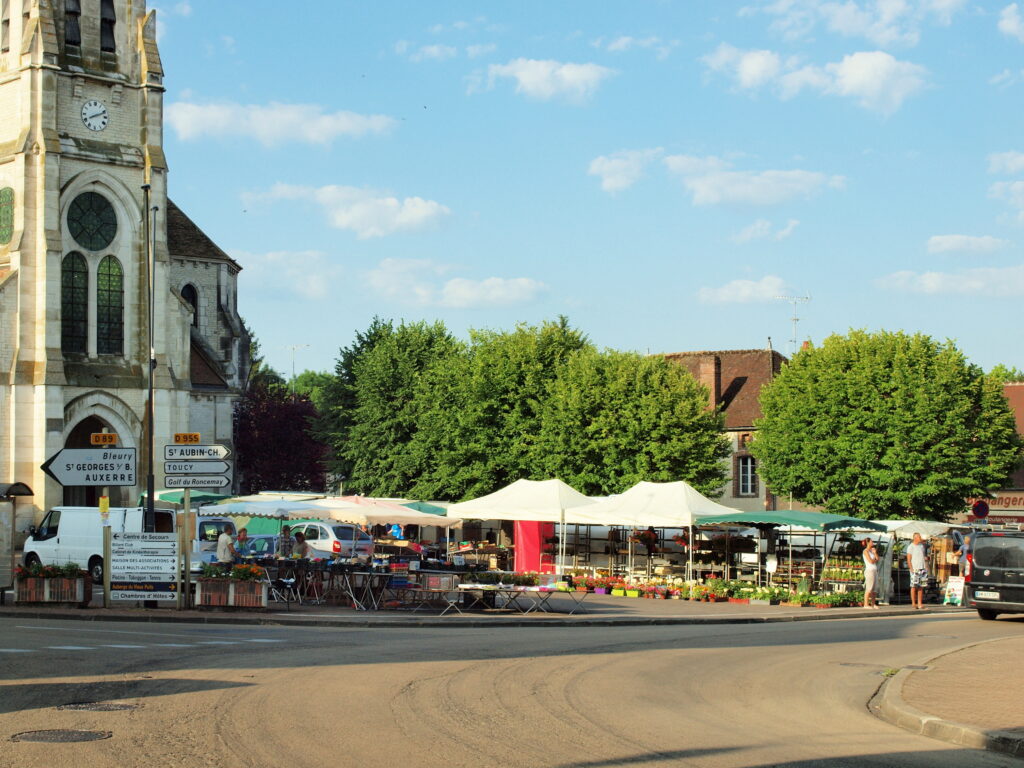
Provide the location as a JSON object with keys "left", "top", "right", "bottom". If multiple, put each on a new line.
{"left": 740, "top": 0, "right": 967, "bottom": 47}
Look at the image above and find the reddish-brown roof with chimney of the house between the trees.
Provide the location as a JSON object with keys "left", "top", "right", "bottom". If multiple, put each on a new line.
{"left": 665, "top": 349, "right": 786, "bottom": 429}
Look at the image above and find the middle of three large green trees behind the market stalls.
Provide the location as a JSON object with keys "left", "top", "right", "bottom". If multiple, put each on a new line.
{"left": 411, "top": 316, "right": 589, "bottom": 499}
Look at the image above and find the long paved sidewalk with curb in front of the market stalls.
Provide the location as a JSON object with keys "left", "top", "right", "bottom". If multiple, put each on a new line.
{"left": 0, "top": 595, "right": 964, "bottom": 628}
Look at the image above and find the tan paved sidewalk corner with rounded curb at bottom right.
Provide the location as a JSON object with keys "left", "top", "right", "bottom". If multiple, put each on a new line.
{"left": 874, "top": 638, "right": 1024, "bottom": 757}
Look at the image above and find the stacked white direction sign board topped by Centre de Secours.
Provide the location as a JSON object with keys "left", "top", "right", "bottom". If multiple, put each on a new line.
{"left": 111, "top": 532, "right": 179, "bottom": 600}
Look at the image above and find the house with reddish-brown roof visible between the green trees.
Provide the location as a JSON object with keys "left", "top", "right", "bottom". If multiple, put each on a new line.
{"left": 665, "top": 349, "right": 786, "bottom": 512}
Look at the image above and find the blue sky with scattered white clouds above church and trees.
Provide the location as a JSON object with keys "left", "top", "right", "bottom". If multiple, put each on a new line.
{"left": 151, "top": 0, "right": 1024, "bottom": 373}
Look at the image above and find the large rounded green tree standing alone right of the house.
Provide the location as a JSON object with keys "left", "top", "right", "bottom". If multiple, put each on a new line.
{"left": 752, "top": 331, "right": 1021, "bottom": 520}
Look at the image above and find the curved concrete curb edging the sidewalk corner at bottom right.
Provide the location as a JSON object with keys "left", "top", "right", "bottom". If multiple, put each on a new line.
{"left": 868, "top": 637, "right": 1024, "bottom": 758}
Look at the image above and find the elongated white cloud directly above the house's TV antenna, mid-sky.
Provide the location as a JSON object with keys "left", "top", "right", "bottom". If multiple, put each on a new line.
{"left": 665, "top": 155, "right": 845, "bottom": 206}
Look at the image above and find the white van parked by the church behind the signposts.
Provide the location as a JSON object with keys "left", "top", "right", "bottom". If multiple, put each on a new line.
{"left": 25, "top": 507, "right": 174, "bottom": 584}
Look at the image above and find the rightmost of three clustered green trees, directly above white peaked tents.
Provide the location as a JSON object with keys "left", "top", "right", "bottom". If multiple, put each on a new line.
{"left": 537, "top": 349, "right": 730, "bottom": 496}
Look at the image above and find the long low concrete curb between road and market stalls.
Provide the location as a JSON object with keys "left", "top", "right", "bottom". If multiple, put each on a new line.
{"left": 0, "top": 606, "right": 953, "bottom": 629}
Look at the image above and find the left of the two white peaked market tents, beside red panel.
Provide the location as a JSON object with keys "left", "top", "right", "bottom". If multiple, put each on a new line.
{"left": 447, "top": 477, "right": 594, "bottom": 570}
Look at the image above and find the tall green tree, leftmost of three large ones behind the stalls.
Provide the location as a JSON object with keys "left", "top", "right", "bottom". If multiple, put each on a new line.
{"left": 337, "top": 322, "right": 461, "bottom": 496}
